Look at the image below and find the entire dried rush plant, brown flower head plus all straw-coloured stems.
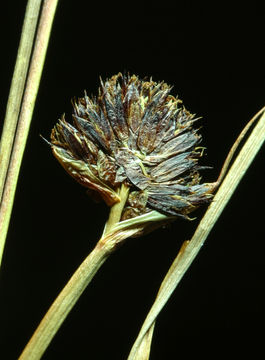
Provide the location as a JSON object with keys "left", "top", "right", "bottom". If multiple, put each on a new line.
{"left": 0, "top": 0, "right": 265, "bottom": 360}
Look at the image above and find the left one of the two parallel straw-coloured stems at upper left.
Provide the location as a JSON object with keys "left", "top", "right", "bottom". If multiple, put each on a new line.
{"left": 0, "top": 0, "right": 41, "bottom": 200}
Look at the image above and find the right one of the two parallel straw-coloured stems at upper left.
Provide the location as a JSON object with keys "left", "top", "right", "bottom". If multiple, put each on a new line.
{"left": 0, "top": 0, "right": 58, "bottom": 262}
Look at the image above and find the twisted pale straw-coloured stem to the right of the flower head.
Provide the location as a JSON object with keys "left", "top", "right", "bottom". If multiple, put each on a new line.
{"left": 128, "top": 111, "right": 265, "bottom": 360}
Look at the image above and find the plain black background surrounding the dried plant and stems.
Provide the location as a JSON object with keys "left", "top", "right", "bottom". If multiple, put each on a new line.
{"left": 0, "top": 1, "right": 265, "bottom": 360}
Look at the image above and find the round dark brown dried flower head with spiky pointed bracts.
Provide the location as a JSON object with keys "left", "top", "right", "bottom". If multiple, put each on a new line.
{"left": 51, "top": 74, "right": 213, "bottom": 220}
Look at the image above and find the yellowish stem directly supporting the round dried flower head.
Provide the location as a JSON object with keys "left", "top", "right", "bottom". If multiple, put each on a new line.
{"left": 19, "top": 185, "right": 130, "bottom": 360}
